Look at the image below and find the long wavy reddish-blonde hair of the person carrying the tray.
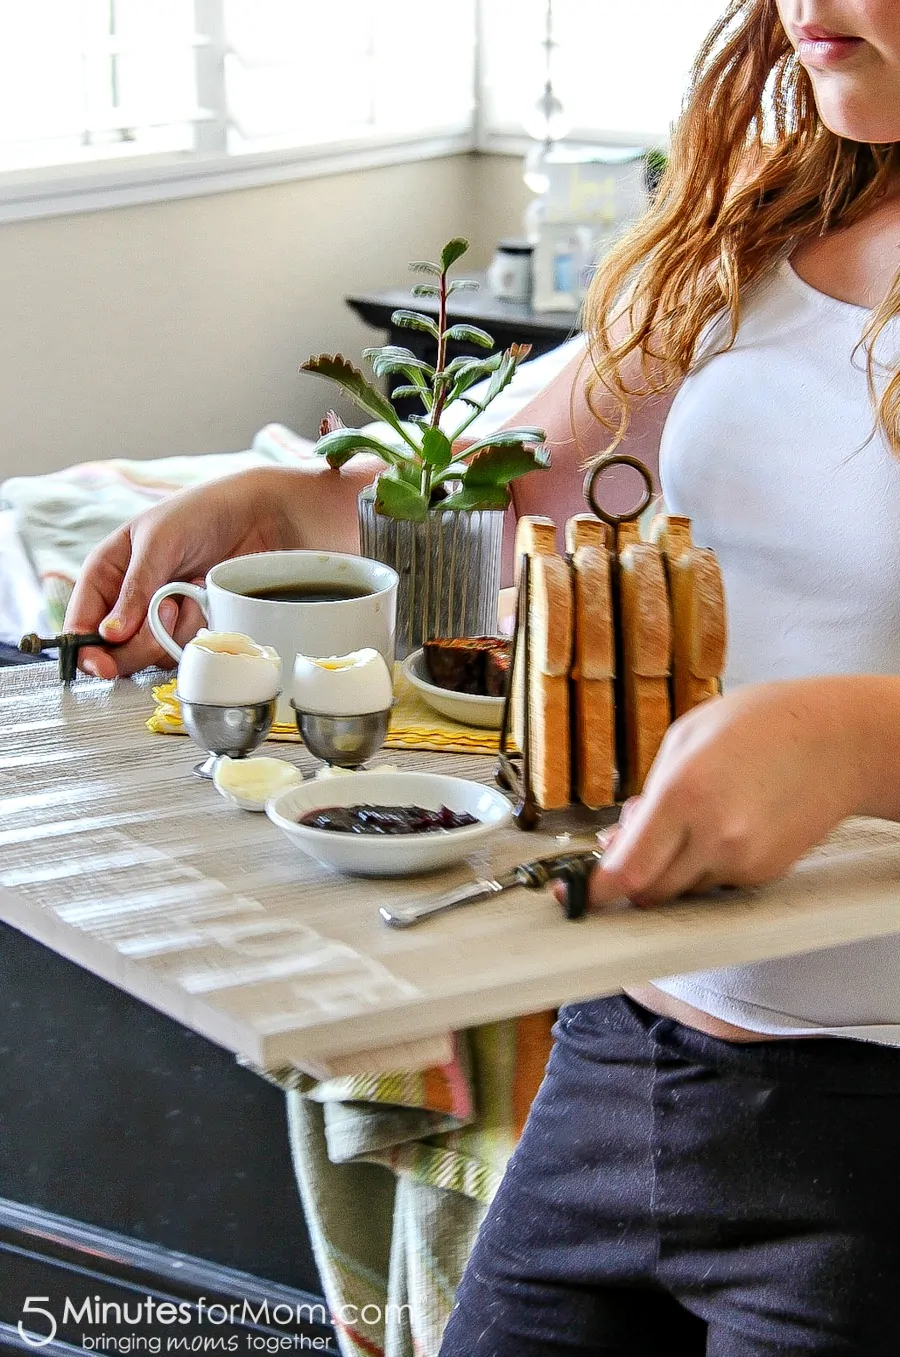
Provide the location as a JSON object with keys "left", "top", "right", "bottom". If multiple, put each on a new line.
{"left": 584, "top": 0, "right": 900, "bottom": 455}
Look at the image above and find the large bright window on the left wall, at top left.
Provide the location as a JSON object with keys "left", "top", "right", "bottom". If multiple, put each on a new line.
{"left": 0, "top": 0, "right": 475, "bottom": 191}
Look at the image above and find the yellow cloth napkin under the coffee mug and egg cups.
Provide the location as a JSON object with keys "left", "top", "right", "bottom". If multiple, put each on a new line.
{"left": 147, "top": 665, "right": 513, "bottom": 754}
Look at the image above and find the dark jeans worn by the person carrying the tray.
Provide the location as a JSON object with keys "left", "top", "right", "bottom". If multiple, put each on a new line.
{"left": 441, "top": 997, "right": 900, "bottom": 1357}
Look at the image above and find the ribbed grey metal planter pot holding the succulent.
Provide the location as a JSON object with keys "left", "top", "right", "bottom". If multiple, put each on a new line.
{"left": 360, "top": 491, "right": 505, "bottom": 660}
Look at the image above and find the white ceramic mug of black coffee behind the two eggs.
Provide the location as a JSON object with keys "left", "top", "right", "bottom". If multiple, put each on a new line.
{"left": 147, "top": 551, "right": 398, "bottom": 723}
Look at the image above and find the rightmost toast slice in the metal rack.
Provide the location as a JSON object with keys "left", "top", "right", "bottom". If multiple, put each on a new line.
{"left": 650, "top": 514, "right": 728, "bottom": 718}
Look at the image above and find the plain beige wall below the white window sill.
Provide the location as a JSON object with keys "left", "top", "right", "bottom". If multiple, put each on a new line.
{"left": 0, "top": 155, "right": 524, "bottom": 479}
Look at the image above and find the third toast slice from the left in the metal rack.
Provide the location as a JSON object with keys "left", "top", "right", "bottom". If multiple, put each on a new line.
{"left": 618, "top": 524, "right": 672, "bottom": 797}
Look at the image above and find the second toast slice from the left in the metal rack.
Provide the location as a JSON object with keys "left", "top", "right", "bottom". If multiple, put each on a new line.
{"left": 566, "top": 540, "right": 616, "bottom": 809}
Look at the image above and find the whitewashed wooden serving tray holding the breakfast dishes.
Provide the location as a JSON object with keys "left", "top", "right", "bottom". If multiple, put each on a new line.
{"left": 0, "top": 664, "right": 900, "bottom": 1072}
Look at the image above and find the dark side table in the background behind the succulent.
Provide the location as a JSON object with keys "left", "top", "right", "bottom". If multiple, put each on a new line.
{"left": 345, "top": 264, "right": 578, "bottom": 414}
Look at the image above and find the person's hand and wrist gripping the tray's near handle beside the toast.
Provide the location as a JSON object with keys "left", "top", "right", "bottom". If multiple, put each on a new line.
{"left": 570, "top": 677, "right": 874, "bottom": 905}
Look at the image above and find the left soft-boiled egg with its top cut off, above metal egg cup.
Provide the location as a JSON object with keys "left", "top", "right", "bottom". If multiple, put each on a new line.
{"left": 178, "top": 627, "right": 281, "bottom": 707}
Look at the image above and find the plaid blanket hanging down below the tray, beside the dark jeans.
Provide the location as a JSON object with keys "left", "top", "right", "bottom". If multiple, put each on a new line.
{"left": 253, "top": 1012, "right": 555, "bottom": 1357}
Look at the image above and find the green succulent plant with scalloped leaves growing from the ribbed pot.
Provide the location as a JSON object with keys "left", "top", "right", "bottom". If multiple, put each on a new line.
{"left": 300, "top": 237, "right": 550, "bottom": 522}
